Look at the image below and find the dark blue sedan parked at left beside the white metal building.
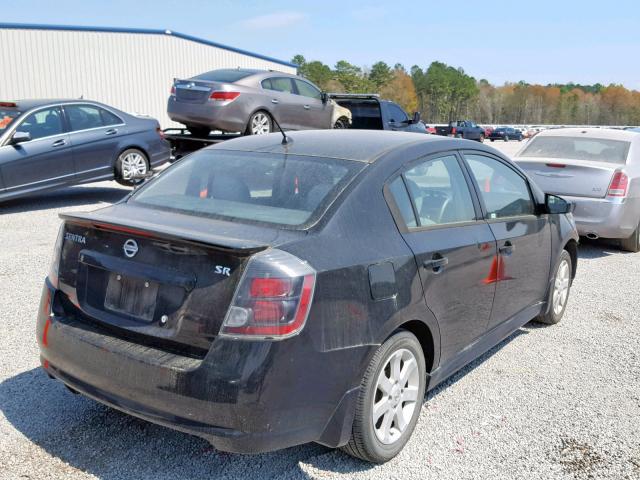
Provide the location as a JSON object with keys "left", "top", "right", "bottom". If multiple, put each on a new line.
{"left": 0, "top": 100, "right": 169, "bottom": 201}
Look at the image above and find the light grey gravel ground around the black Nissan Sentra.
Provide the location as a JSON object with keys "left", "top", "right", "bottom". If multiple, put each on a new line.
{"left": 0, "top": 142, "right": 640, "bottom": 480}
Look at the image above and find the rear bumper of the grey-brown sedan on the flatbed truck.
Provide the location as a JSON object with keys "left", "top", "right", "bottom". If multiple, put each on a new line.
{"left": 167, "top": 97, "right": 249, "bottom": 132}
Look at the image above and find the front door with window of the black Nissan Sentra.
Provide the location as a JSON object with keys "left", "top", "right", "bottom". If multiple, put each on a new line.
{"left": 464, "top": 151, "right": 551, "bottom": 329}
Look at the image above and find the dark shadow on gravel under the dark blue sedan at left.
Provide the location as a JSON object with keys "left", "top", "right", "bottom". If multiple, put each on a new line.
{"left": 0, "top": 184, "right": 131, "bottom": 215}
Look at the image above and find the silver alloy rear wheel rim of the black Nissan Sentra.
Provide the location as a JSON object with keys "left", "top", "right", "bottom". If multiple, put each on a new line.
{"left": 371, "top": 348, "right": 420, "bottom": 445}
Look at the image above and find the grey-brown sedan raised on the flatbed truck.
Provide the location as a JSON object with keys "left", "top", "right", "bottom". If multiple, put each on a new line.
{"left": 167, "top": 68, "right": 348, "bottom": 137}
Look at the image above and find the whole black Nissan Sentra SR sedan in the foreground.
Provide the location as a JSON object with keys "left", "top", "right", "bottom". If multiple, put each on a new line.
{"left": 37, "top": 130, "right": 578, "bottom": 462}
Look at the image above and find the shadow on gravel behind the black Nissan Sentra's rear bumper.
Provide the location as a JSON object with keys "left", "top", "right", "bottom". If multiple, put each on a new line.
{"left": 0, "top": 368, "right": 338, "bottom": 480}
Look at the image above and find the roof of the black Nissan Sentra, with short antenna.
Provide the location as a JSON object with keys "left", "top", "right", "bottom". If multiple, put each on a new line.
{"left": 208, "top": 129, "right": 451, "bottom": 163}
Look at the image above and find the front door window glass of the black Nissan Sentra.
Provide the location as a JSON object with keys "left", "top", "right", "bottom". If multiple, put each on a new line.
{"left": 465, "top": 154, "right": 535, "bottom": 219}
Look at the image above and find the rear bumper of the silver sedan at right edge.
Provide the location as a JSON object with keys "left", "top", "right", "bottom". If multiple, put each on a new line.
{"left": 562, "top": 195, "right": 640, "bottom": 238}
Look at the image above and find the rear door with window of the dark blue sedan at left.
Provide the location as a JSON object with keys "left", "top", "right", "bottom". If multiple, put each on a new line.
{"left": 62, "top": 103, "right": 126, "bottom": 181}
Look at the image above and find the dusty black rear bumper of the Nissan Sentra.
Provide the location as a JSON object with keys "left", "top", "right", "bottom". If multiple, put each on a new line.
{"left": 37, "top": 282, "right": 366, "bottom": 453}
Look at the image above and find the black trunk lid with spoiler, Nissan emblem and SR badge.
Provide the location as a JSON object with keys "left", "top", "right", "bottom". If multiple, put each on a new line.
{"left": 58, "top": 205, "right": 304, "bottom": 356}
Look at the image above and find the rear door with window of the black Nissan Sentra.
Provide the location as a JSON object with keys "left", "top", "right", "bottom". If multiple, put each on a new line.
{"left": 387, "top": 153, "right": 496, "bottom": 362}
